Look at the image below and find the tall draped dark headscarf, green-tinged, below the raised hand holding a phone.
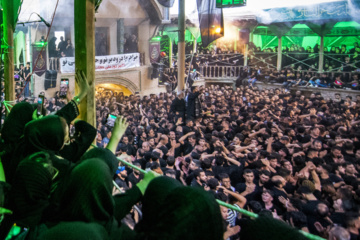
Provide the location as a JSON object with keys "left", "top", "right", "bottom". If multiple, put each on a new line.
{"left": 60, "top": 159, "right": 114, "bottom": 226}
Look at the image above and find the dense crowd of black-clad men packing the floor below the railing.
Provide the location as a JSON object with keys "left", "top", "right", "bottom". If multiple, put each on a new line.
{"left": 92, "top": 83, "right": 360, "bottom": 239}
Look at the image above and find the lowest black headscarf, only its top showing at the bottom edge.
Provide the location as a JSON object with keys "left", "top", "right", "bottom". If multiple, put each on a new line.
{"left": 38, "top": 222, "right": 109, "bottom": 240}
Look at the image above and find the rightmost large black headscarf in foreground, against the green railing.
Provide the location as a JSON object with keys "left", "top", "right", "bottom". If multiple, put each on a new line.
{"left": 136, "top": 180, "right": 224, "bottom": 240}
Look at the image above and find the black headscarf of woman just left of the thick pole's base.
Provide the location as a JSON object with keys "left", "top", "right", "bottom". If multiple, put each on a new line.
{"left": 24, "top": 115, "right": 65, "bottom": 152}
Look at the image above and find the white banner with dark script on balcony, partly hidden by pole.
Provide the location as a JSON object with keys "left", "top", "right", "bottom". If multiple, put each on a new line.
{"left": 60, "top": 53, "right": 140, "bottom": 73}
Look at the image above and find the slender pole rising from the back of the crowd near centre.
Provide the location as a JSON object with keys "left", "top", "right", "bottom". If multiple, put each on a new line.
{"left": 178, "top": 0, "right": 185, "bottom": 92}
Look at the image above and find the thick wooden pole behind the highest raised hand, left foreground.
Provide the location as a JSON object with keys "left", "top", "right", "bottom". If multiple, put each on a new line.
{"left": 75, "top": 0, "right": 96, "bottom": 127}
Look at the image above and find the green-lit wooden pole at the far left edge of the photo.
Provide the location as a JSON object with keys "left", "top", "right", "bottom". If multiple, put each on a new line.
{"left": 1, "top": 0, "right": 15, "bottom": 101}
